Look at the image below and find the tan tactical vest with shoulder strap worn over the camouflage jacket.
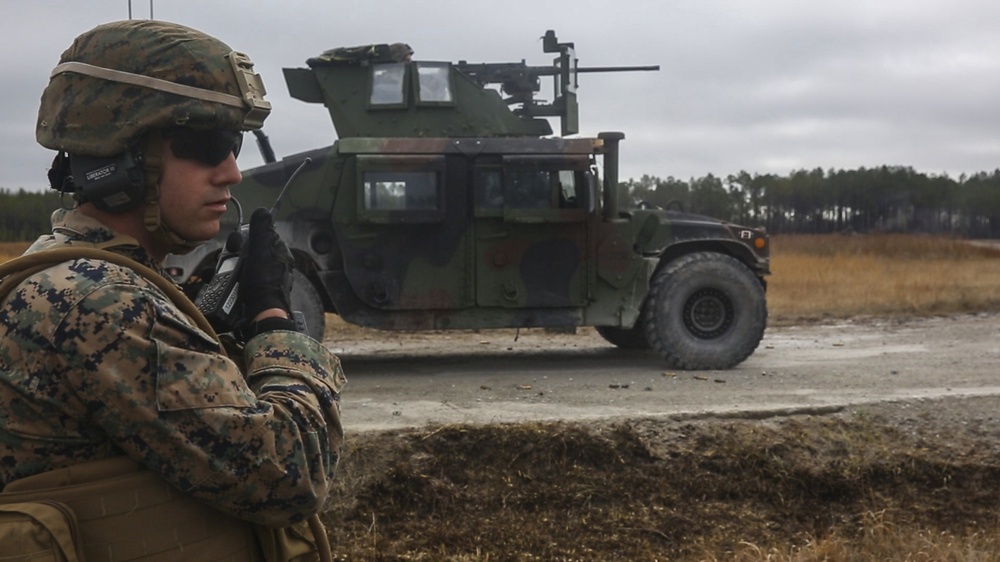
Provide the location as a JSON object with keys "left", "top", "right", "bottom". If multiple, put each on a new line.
{"left": 0, "top": 246, "right": 332, "bottom": 562}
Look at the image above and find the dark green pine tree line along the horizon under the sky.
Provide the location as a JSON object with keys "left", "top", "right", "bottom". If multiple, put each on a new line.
{"left": 0, "top": 166, "right": 1000, "bottom": 242}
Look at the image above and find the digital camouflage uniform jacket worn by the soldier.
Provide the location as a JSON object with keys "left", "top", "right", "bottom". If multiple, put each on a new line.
{"left": 0, "top": 206, "right": 346, "bottom": 526}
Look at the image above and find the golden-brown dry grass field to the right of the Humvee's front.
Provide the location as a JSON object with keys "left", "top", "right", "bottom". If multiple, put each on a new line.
{"left": 767, "top": 235, "right": 1000, "bottom": 324}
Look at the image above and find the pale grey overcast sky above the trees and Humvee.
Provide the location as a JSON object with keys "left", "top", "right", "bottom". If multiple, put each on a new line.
{"left": 0, "top": 0, "right": 1000, "bottom": 190}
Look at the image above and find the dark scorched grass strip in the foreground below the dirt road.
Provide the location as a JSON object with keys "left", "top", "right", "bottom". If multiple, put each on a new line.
{"left": 323, "top": 401, "right": 1000, "bottom": 561}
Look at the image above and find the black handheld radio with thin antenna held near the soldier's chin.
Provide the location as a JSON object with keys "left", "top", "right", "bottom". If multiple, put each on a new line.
{"left": 195, "top": 158, "right": 312, "bottom": 334}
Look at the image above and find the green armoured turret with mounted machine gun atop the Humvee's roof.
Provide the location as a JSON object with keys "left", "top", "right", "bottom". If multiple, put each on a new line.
{"left": 284, "top": 30, "right": 660, "bottom": 138}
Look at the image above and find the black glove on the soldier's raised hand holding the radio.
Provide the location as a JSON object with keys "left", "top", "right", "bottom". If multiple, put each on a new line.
{"left": 240, "top": 207, "right": 294, "bottom": 322}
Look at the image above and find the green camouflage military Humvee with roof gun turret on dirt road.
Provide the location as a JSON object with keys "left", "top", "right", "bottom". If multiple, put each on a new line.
{"left": 168, "top": 31, "right": 769, "bottom": 369}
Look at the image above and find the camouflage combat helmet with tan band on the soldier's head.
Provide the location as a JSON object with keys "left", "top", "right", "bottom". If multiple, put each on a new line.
{"left": 35, "top": 20, "right": 271, "bottom": 156}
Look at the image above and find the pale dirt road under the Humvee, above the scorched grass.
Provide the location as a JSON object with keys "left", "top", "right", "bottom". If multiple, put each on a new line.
{"left": 327, "top": 315, "right": 1000, "bottom": 431}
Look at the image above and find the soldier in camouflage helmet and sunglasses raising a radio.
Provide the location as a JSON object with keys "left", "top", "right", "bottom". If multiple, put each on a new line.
{"left": 0, "top": 20, "right": 346, "bottom": 560}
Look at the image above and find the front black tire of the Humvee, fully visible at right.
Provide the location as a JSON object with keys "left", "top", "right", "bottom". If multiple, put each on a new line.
{"left": 643, "top": 252, "right": 767, "bottom": 370}
